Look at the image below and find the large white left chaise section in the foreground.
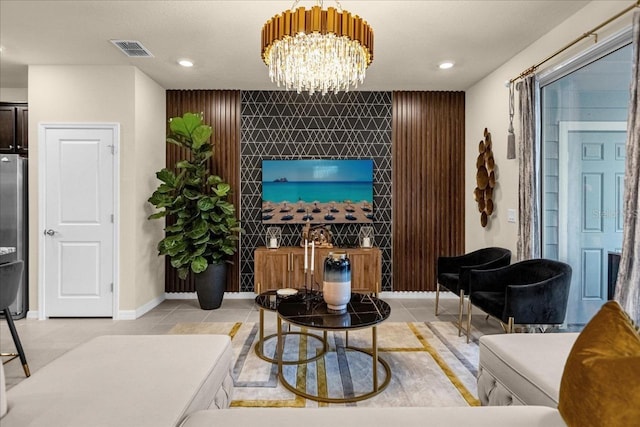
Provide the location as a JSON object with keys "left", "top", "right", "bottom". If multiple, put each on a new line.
{"left": 0, "top": 335, "right": 233, "bottom": 427}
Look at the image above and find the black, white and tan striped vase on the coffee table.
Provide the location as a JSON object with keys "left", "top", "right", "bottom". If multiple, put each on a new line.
{"left": 322, "top": 252, "right": 351, "bottom": 312}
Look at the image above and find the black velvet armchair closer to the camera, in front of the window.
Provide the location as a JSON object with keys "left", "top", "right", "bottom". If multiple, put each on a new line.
{"left": 467, "top": 258, "right": 571, "bottom": 342}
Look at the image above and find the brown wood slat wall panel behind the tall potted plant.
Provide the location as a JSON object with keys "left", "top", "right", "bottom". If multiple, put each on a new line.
{"left": 165, "top": 90, "right": 240, "bottom": 292}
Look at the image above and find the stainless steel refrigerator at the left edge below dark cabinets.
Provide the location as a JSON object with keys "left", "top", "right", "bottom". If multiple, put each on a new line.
{"left": 0, "top": 154, "right": 29, "bottom": 319}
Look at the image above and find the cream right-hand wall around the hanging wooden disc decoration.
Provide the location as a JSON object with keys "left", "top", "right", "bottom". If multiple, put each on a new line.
{"left": 465, "top": 1, "right": 632, "bottom": 257}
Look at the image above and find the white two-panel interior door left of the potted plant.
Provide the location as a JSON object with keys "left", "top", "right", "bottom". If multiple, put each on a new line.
{"left": 40, "top": 125, "right": 118, "bottom": 317}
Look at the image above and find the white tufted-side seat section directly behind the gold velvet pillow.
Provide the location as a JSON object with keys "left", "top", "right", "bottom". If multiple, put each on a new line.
{"left": 478, "top": 333, "right": 578, "bottom": 408}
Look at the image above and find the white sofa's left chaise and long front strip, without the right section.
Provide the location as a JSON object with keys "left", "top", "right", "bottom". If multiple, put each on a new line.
{"left": 0, "top": 335, "right": 565, "bottom": 427}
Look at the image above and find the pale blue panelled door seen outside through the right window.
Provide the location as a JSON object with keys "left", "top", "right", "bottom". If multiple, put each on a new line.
{"left": 559, "top": 122, "right": 626, "bottom": 324}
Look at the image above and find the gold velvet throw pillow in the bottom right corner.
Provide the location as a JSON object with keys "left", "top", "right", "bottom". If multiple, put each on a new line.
{"left": 558, "top": 301, "right": 640, "bottom": 427}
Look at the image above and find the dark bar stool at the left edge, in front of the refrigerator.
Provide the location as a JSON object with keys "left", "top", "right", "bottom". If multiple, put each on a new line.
{"left": 0, "top": 261, "right": 31, "bottom": 377}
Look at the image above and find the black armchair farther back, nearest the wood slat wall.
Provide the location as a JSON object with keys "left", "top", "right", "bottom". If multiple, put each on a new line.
{"left": 436, "top": 247, "right": 511, "bottom": 341}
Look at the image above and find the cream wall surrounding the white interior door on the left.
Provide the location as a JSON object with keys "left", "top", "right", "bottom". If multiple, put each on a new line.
{"left": 28, "top": 66, "right": 165, "bottom": 317}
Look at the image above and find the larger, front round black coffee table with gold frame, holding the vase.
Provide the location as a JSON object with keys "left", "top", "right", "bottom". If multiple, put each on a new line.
{"left": 277, "top": 293, "right": 391, "bottom": 403}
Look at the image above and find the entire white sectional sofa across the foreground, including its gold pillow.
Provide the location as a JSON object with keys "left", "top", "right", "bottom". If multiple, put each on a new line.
{"left": 0, "top": 302, "right": 640, "bottom": 427}
